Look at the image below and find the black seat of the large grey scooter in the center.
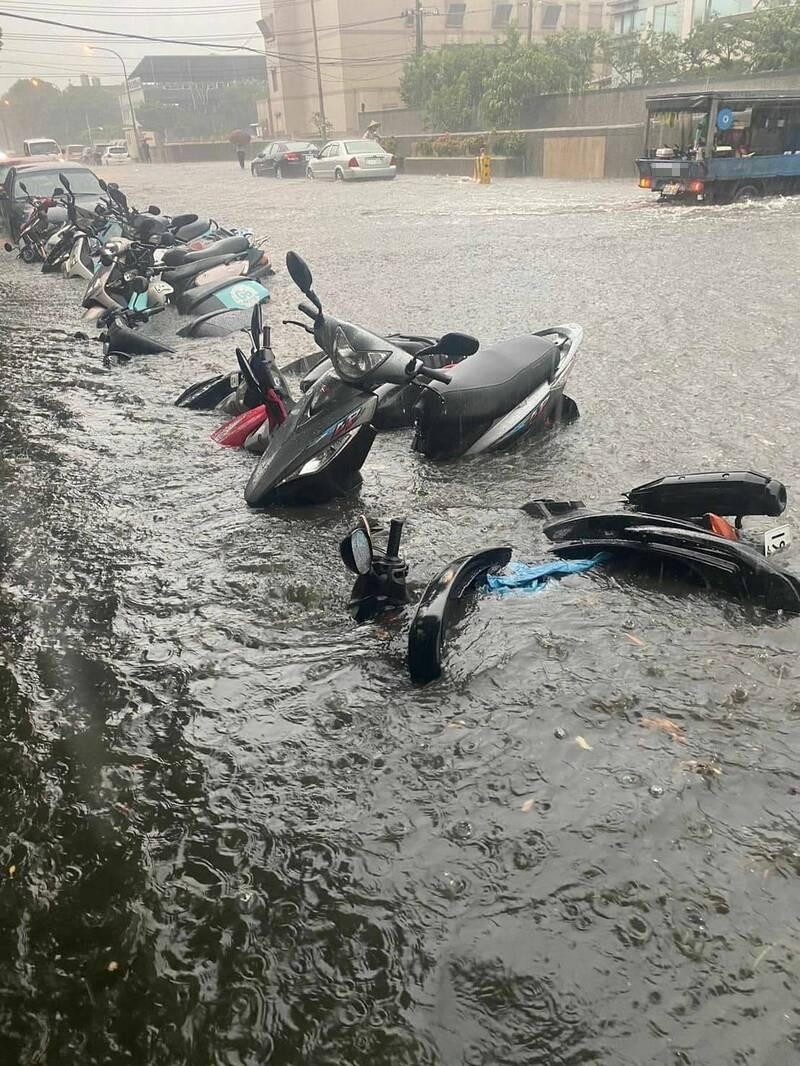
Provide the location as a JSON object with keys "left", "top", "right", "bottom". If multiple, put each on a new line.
{"left": 415, "top": 334, "right": 561, "bottom": 421}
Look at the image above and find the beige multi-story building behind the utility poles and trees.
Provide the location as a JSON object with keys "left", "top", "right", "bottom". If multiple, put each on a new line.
{"left": 259, "top": 0, "right": 608, "bottom": 134}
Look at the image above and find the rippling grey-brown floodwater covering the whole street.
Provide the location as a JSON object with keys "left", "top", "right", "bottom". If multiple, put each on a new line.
{"left": 0, "top": 162, "right": 800, "bottom": 1066}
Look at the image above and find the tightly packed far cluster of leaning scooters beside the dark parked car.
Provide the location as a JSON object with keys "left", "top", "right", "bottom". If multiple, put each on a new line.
{"left": 5, "top": 173, "right": 273, "bottom": 354}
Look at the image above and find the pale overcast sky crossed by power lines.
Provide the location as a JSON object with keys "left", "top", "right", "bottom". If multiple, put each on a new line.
{"left": 0, "top": 0, "right": 262, "bottom": 89}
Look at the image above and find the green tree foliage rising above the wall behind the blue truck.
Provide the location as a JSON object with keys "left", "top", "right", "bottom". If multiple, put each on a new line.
{"left": 400, "top": 0, "right": 800, "bottom": 130}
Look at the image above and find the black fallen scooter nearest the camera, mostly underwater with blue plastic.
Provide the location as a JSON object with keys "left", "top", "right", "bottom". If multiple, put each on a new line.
{"left": 339, "top": 471, "right": 800, "bottom": 683}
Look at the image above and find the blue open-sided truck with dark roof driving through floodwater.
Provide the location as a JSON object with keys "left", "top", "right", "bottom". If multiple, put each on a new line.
{"left": 636, "top": 90, "right": 800, "bottom": 204}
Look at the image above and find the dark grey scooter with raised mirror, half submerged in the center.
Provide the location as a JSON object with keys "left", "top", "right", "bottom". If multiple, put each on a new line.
{"left": 244, "top": 252, "right": 583, "bottom": 505}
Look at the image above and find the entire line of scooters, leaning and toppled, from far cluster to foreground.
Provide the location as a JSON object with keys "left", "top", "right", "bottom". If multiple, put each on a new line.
{"left": 6, "top": 175, "right": 800, "bottom": 681}
